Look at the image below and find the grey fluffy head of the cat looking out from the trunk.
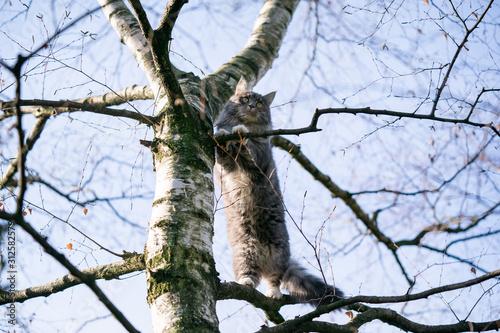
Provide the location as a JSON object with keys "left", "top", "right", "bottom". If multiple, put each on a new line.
{"left": 218, "top": 77, "right": 276, "bottom": 131}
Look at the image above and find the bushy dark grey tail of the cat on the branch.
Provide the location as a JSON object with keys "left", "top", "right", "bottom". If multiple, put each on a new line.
{"left": 281, "top": 260, "right": 344, "bottom": 306}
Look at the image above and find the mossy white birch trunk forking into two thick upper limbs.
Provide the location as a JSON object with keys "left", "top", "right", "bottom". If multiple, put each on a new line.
{"left": 99, "top": 0, "right": 298, "bottom": 332}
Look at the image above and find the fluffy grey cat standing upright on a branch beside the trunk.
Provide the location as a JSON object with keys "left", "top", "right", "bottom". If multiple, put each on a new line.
{"left": 215, "top": 78, "right": 343, "bottom": 305}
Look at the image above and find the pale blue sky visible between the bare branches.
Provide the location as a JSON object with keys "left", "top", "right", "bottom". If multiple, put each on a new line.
{"left": 0, "top": 1, "right": 500, "bottom": 332}
